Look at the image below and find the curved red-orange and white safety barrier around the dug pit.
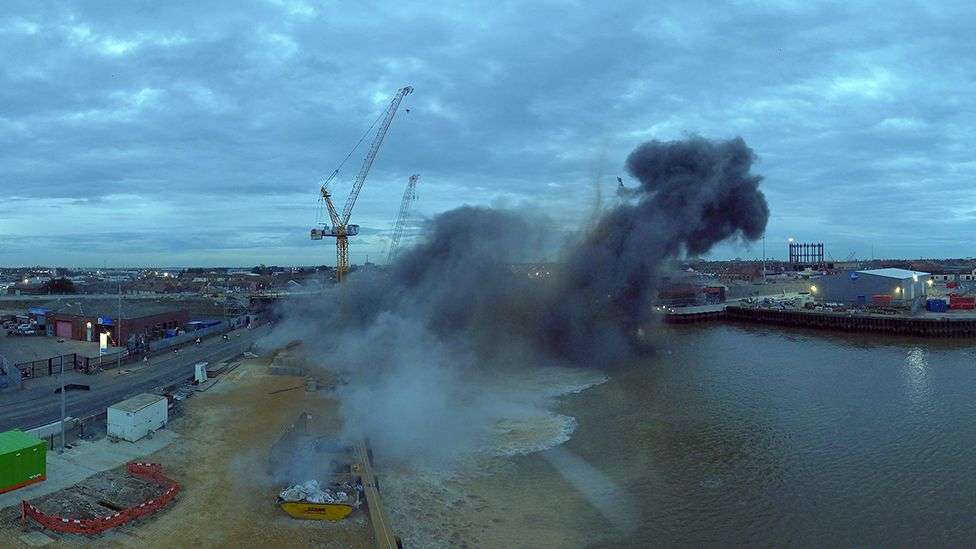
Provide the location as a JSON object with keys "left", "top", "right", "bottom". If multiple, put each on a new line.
{"left": 21, "top": 462, "right": 180, "bottom": 536}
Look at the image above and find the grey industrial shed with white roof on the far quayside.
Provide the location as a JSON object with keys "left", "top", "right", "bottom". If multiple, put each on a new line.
{"left": 811, "top": 268, "right": 931, "bottom": 305}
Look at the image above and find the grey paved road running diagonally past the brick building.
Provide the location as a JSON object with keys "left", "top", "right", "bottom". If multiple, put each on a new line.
{"left": 0, "top": 326, "right": 269, "bottom": 432}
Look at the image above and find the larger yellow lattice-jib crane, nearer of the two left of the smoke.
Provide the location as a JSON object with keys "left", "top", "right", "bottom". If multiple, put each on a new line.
{"left": 311, "top": 86, "right": 413, "bottom": 282}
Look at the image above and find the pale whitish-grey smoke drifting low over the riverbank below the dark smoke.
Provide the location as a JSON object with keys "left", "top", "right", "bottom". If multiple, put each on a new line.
{"left": 265, "top": 268, "right": 580, "bottom": 472}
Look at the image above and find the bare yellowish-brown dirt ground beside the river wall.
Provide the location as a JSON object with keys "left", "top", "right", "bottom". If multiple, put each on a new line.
{"left": 0, "top": 359, "right": 372, "bottom": 548}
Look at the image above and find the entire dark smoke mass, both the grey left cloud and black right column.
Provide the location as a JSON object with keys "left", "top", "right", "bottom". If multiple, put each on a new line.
{"left": 308, "top": 137, "right": 769, "bottom": 365}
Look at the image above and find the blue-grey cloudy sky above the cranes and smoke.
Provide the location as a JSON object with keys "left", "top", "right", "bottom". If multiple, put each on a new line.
{"left": 0, "top": 0, "right": 976, "bottom": 266}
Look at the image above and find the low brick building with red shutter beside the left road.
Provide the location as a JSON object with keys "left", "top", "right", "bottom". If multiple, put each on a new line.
{"left": 44, "top": 300, "right": 190, "bottom": 348}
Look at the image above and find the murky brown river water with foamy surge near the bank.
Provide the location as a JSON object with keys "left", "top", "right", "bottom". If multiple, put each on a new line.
{"left": 392, "top": 323, "right": 976, "bottom": 547}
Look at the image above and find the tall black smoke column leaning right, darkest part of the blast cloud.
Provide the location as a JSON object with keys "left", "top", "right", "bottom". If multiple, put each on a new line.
{"left": 546, "top": 137, "right": 769, "bottom": 363}
